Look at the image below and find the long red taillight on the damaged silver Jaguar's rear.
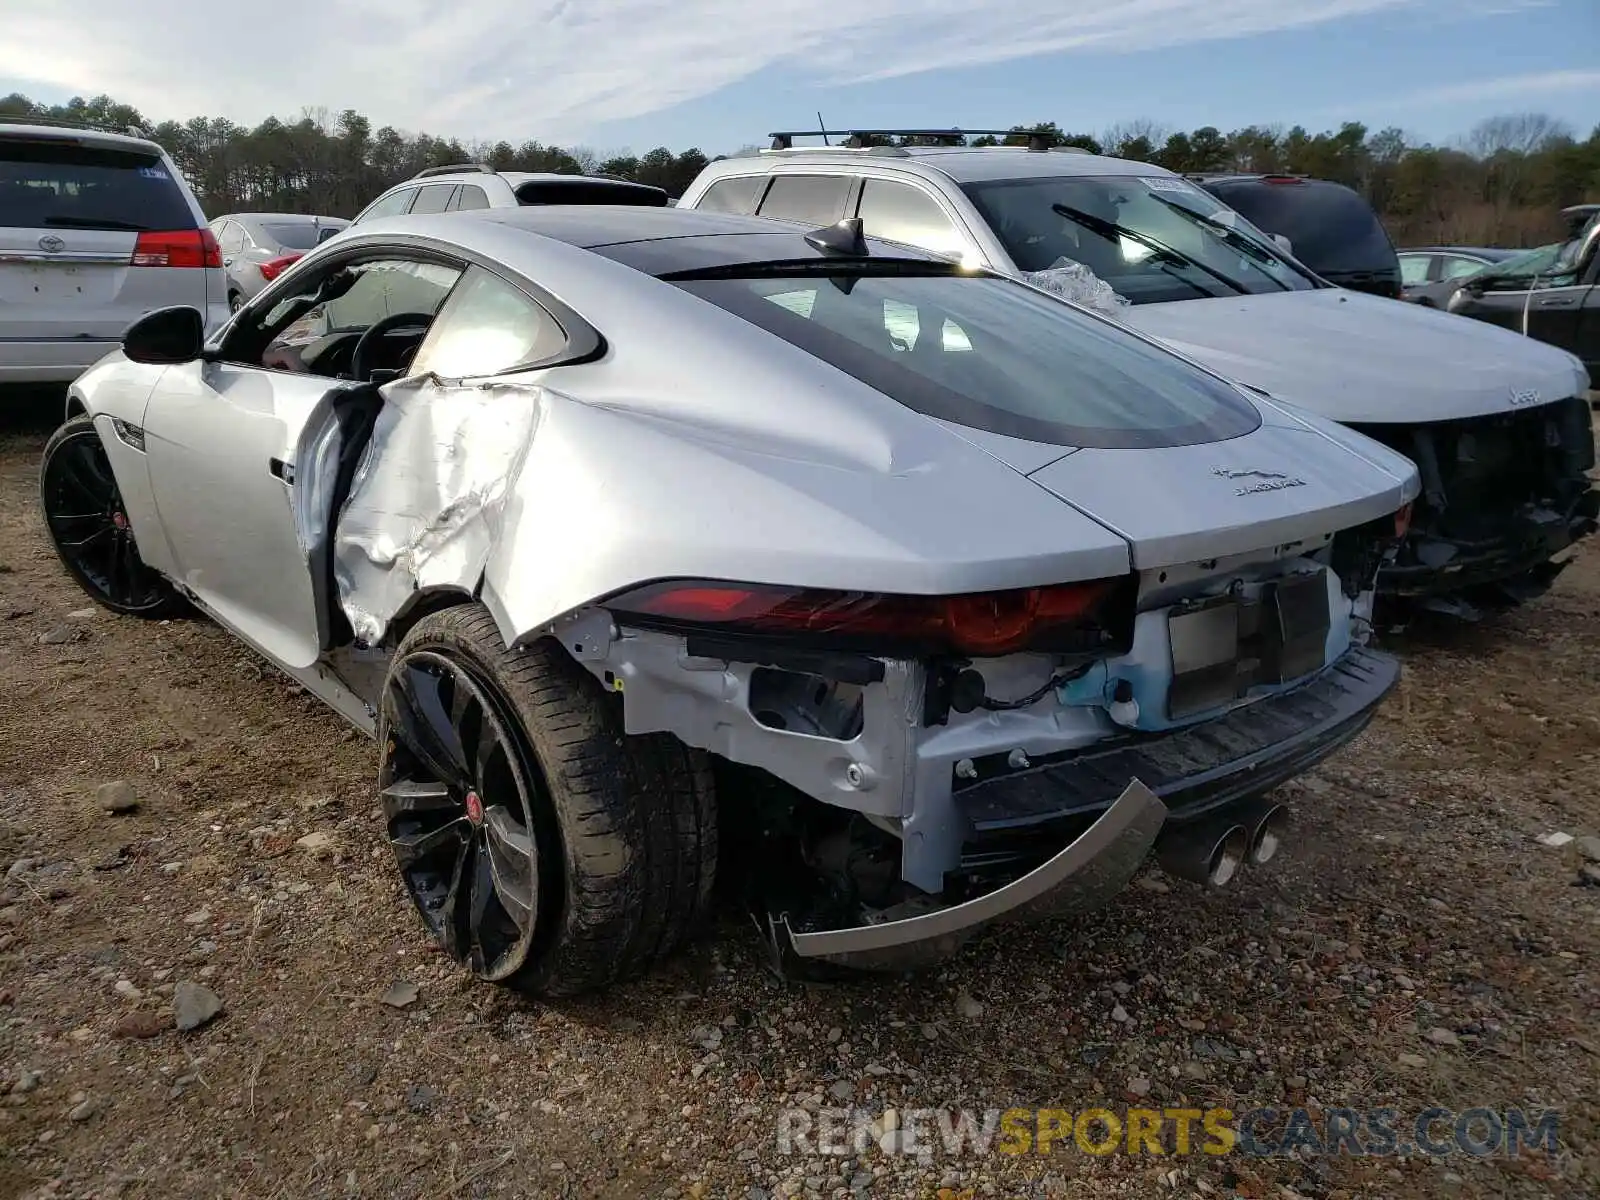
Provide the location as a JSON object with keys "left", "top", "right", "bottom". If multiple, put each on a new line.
{"left": 610, "top": 579, "right": 1117, "bottom": 656}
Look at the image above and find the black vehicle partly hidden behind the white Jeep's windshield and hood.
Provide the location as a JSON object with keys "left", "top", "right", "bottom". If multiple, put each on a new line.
{"left": 1187, "top": 174, "right": 1400, "bottom": 299}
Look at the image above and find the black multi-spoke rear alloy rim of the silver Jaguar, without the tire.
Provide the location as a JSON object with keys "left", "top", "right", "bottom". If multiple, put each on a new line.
{"left": 379, "top": 650, "right": 552, "bottom": 982}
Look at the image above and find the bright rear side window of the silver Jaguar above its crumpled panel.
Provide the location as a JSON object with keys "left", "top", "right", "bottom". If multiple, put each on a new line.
{"left": 408, "top": 267, "right": 566, "bottom": 379}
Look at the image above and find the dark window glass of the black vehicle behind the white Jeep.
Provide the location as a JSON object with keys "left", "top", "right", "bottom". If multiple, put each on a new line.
{"left": 1216, "top": 181, "right": 1398, "bottom": 272}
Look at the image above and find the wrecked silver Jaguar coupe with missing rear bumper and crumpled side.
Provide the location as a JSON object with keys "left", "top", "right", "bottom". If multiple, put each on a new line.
{"left": 40, "top": 206, "right": 1419, "bottom": 995}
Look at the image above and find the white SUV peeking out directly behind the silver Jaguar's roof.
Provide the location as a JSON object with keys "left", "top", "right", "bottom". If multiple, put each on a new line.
{"left": 354, "top": 163, "right": 670, "bottom": 224}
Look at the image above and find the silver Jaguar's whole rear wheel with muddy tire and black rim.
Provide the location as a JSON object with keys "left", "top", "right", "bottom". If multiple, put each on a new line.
{"left": 379, "top": 605, "right": 717, "bottom": 997}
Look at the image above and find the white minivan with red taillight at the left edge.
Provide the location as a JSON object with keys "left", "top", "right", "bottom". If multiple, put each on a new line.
{"left": 0, "top": 117, "right": 227, "bottom": 384}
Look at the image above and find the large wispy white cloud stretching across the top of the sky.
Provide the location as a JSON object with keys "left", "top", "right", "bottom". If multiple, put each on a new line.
{"left": 0, "top": 0, "right": 1546, "bottom": 141}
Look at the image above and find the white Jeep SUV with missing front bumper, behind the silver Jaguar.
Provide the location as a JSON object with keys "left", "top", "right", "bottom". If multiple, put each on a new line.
{"left": 678, "top": 131, "right": 1600, "bottom": 621}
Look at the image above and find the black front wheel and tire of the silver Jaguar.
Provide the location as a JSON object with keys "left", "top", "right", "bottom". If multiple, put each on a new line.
{"left": 38, "top": 414, "right": 187, "bottom": 618}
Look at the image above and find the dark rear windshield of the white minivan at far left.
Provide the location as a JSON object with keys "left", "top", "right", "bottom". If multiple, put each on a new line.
{"left": 0, "top": 138, "right": 198, "bottom": 230}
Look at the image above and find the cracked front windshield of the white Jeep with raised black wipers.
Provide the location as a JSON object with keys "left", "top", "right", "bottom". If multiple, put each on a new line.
{"left": 965, "top": 176, "right": 1320, "bottom": 304}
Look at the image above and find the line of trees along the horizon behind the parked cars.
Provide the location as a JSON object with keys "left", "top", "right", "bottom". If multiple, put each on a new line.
{"left": 0, "top": 94, "right": 1600, "bottom": 246}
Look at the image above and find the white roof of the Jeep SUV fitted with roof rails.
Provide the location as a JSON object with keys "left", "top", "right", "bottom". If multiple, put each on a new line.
{"left": 710, "top": 146, "right": 1174, "bottom": 182}
